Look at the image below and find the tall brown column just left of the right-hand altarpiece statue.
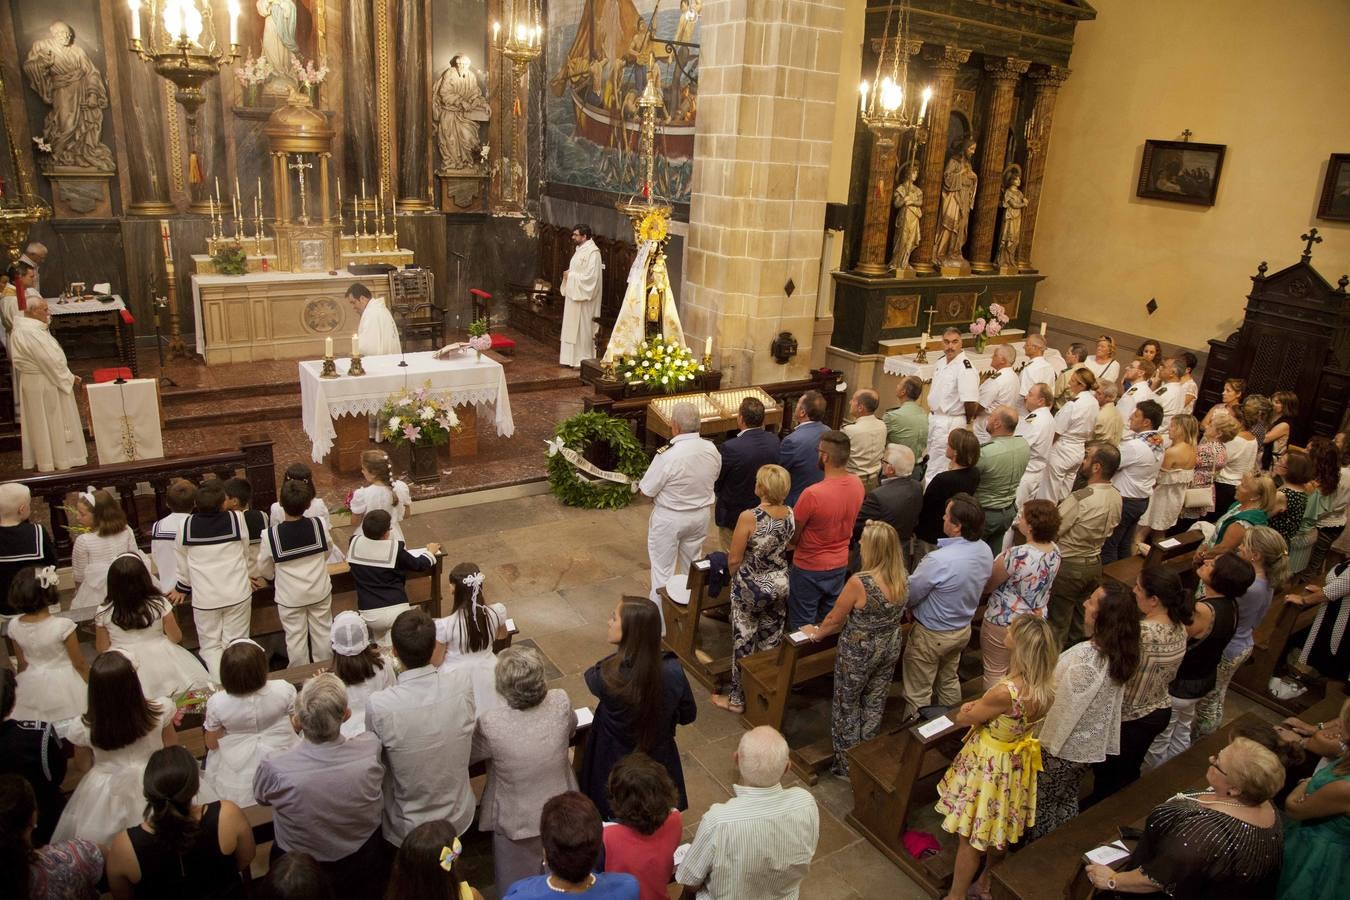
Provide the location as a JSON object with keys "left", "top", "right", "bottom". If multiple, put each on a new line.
{"left": 393, "top": 0, "right": 431, "bottom": 209}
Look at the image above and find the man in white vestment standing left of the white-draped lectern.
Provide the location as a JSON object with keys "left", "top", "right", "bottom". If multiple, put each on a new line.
{"left": 9, "top": 297, "right": 89, "bottom": 472}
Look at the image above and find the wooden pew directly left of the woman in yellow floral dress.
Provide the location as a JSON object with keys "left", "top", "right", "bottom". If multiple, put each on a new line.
{"left": 848, "top": 719, "right": 968, "bottom": 896}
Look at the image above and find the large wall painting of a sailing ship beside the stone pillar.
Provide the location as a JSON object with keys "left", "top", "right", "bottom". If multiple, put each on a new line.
{"left": 545, "top": 0, "right": 703, "bottom": 204}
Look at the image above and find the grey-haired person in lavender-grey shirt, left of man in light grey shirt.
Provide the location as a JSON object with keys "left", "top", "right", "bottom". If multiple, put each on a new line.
{"left": 254, "top": 672, "right": 389, "bottom": 897}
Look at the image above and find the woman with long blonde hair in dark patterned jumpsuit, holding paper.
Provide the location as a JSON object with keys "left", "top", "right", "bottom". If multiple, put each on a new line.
{"left": 802, "top": 519, "right": 910, "bottom": 777}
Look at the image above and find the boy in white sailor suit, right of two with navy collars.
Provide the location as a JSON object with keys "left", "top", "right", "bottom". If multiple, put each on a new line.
{"left": 258, "top": 482, "right": 333, "bottom": 668}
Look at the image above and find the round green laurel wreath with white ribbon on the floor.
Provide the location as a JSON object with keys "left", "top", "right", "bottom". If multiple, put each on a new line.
{"left": 548, "top": 413, "right": 648, "bottom": 509}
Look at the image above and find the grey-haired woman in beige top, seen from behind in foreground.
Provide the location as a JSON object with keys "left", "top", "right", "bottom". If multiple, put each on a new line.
{"left": 477, "top": 646, "right": 576, "bottom": 893}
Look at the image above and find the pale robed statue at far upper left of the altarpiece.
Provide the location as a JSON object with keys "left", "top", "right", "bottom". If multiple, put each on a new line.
{"left": 23, "top": 22, "right": 115, "bottom": 171}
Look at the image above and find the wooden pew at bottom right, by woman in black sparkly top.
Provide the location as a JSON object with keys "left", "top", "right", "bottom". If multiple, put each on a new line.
{"left": 991, "top": 714, "right": 1264, "bottom": 900}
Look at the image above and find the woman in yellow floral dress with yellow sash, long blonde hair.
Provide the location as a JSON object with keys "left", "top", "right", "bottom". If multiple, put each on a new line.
{"left": 937, "top": 615, "right": 1060, "bottom": 900}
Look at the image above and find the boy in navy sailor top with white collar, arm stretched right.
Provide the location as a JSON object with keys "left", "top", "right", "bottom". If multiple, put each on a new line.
{"left": 347, "top": 510, "right": 440, "bottom": 646}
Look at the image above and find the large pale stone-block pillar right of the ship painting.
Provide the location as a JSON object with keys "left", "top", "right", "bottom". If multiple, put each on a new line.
{"left": 680, "top": 0, "right": 852, "bottom": 386}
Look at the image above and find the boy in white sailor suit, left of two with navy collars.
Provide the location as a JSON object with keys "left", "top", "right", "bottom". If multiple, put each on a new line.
{"left": 169, "top": 479, "right": 263, "bottom": 681}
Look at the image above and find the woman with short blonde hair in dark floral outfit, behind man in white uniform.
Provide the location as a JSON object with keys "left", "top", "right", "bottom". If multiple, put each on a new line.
{"left": 711, "top": 466, "right": 797, "bottom": 714}
